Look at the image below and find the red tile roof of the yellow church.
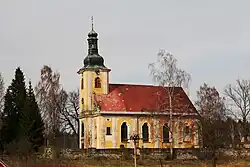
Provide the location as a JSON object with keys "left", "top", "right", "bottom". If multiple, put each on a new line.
{"left": 95, "top": 84, "right": 196, "bottom": 113}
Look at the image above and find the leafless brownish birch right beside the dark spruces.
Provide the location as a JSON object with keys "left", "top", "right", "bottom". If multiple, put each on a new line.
{"left": 35, "top": 65, "right": 63, "bottom": 145}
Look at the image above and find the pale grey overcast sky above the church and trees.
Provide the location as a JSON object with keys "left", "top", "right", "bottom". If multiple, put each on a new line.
{"left": 0, "top": 0, "right": 250, "bottom": 99}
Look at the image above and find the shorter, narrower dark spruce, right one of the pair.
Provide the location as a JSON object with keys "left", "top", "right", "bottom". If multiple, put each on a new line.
{"left": 23, "top": 82, "right": 45, "bottom": 152}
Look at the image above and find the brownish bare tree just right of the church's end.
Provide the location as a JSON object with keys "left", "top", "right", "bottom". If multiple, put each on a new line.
{"left": 195, "top": 83, "right": 230, "bottom": 166}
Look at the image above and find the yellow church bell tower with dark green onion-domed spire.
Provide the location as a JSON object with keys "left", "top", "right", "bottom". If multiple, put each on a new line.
{"left": 78, "top": 17, "right": 111, "bottom": 148}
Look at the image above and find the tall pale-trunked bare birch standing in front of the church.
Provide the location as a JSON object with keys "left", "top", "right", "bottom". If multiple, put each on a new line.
{"left": 149, "top": 50, "right": 191, "bottom": 158}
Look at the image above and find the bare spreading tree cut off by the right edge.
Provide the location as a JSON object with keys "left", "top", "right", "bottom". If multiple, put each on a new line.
{"left": 224, "top": 79, "right": 250, "bottom": 141}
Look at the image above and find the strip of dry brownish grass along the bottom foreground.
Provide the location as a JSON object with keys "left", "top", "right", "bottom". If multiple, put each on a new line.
{"left": 1, "top": 159, "right": 250, "bottom": 167}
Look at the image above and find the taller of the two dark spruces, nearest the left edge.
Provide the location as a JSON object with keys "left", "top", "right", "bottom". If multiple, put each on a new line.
{"left": 2, "top": 67, "right": 26, "bottom": 144}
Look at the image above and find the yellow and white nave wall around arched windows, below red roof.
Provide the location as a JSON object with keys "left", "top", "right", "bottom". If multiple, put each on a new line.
{"left": 92, "top": 115, "right": 199, "bottom": 149}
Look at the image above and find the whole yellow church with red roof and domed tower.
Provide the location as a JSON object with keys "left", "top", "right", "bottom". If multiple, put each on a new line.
{"left": 78, "top": 24, "right": 199, "bottom": 149}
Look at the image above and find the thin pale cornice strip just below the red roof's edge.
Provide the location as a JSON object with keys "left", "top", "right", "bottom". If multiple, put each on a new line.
{"left": 100, "top": 111, "right": 198, "bottom": 116}
